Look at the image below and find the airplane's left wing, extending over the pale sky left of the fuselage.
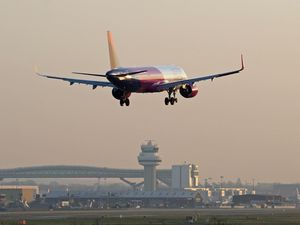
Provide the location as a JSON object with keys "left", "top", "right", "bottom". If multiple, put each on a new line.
{"left": 36, "top": 69, "right": 115, "bottom": 89}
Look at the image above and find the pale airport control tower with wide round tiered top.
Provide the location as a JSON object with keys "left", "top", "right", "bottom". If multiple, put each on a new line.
{"left": 138, "top": 140, "right": 161, "bottom": 191}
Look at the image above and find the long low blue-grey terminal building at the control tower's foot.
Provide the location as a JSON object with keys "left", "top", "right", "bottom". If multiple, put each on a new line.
{"left": 45, "top": 191, "right": 202, "bottom": 208}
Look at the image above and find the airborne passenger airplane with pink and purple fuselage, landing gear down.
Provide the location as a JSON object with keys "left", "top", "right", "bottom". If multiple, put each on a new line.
{"left": 35, "top": 31, "right": 244, "bottom": 106}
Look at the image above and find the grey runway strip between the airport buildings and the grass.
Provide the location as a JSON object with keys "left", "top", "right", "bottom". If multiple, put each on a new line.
{"left": 0, "top": 209, "right": 300, "bottom": 221}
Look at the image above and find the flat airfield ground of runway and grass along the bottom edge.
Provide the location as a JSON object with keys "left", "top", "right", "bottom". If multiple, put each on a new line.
{"left": 0, "top": 209, "right": 300, "bottom": 225}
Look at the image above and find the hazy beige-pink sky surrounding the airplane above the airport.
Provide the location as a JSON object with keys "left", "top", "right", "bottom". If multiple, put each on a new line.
{"left": 0, "top": 0, "right": 300, "bottom": 182}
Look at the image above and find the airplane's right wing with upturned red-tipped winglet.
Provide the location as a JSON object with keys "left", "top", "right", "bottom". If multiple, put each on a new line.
{"left": 157, "top": 56, "right": 244, "bottom": 91}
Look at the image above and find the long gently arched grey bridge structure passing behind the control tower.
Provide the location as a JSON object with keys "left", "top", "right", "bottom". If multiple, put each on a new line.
{"left": 0, "top": 165, "right": 172, "bottom": 186}
